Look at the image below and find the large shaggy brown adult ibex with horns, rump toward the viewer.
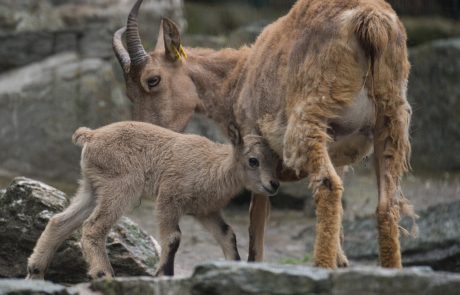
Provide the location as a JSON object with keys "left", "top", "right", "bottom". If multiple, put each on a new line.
{"left": 113, "top": 0, "right": 411, "bottom": 268}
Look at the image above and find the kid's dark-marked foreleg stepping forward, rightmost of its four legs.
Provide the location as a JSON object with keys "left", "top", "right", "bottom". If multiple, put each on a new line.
{"left": 197, "top": 212, "right": 241, "bottom": 260}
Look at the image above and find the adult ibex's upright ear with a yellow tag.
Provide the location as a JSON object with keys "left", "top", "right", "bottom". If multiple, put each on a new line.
{"left": 155, "top": 17, "right": 187, "bottom": 61}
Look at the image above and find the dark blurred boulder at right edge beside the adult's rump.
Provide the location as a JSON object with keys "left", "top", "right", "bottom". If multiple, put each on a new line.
{"left": 408, "top": 39, "right": 460, "bottom": 171}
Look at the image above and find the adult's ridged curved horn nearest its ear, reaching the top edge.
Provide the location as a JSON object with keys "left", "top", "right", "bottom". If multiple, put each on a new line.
{"left": 126, "top": 0, "right": 147, "bottom": 66}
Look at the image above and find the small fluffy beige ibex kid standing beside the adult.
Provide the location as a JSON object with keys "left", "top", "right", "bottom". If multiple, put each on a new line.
{"left": 27, "top": 122, "right": 279, "bottom": 278}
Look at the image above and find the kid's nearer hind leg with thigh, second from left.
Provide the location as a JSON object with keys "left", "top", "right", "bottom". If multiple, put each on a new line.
{"left": 81, "top": 181, "right": 141, "bottom": 279}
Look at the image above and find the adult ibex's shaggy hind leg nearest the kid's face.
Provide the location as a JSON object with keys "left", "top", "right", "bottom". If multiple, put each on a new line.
{"left": 284, "top": 102, "right": 343, "bottom": 268}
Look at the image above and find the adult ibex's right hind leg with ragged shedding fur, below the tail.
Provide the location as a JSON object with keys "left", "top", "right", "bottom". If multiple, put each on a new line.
{"left": 374, "top": 53, "right": 415, "bottom": 268}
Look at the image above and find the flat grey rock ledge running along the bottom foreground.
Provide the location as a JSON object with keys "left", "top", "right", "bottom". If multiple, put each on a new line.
{"left": 0, "top": 262, "right": 460, "bottom": 295}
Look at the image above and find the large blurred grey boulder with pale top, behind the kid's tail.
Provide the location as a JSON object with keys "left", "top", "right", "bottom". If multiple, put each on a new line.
{"left": 0, "top": 53, "right": 131, "bottom": 182}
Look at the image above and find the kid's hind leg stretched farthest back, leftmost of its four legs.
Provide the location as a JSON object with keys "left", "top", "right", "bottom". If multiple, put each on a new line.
{"left": 26, "top": 179, "right": 95, "bottom": 279}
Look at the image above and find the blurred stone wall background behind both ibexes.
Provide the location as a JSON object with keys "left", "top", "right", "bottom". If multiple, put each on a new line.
{"left": 0, "top": 0, "right": 460, "bottom": 202}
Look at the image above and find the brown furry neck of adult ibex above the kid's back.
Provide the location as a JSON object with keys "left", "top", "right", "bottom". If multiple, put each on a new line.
{"left": 187, "top": 47, "right": 251, "bottom": 130}
